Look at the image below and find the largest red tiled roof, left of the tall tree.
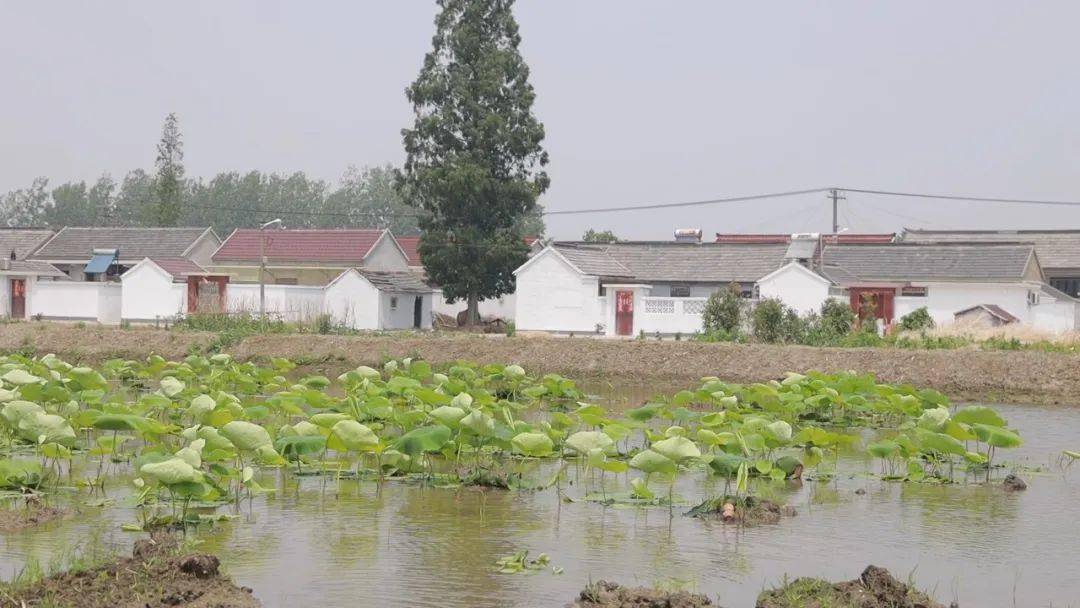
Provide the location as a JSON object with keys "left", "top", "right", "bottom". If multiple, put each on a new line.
{"left": 213, "top": 228, "right": 386, "bottom": 266}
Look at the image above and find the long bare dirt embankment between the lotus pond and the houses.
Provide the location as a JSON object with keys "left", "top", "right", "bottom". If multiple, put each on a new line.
{"left": 0, "top": 323, "right": 1080, "bottom": 404}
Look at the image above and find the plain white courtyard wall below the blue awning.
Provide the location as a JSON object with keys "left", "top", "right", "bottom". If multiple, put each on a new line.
{"left": 26, "top": 281, "right": 121, "bottom": 323}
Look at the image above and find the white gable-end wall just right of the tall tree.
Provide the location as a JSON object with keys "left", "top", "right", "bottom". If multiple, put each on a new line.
{"left": 514, "top": 254, "right": 605, "bottom": 334}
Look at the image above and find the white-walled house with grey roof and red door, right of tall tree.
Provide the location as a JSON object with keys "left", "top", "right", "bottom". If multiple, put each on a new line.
{"left": 514, "top": 242, "right": 787, "bottom": 336}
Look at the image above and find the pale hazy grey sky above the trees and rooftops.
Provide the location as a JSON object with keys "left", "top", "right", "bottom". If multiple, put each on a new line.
{"left": 0, "top": 0, "right": 1080, "bottom": 239}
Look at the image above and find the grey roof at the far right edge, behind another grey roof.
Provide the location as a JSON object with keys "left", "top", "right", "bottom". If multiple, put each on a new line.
{"left": 902, "top": 228, "right": 1080, "bottom": 270}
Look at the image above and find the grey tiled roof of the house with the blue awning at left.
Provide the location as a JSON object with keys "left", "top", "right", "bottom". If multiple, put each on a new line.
{"left": 30, "top": 227, "right": 208, "bottom": 261}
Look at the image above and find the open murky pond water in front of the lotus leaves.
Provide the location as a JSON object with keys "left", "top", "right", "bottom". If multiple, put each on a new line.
{"left": 0, "top": 387, "right": 1080, "bottom": 607}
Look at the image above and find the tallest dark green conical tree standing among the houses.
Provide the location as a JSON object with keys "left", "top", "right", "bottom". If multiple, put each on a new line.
{"left": 396, "top": 0, "right": 550, "bottom": 323}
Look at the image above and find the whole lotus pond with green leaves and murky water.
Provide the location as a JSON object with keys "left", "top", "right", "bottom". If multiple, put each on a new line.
{"left": 0, "top": 355, "right": 1080, "bottom": 607}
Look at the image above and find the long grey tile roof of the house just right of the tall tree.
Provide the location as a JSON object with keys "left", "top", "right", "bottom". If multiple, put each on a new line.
{"left": 554, "top": 241, "right": 787, "bottom": 283}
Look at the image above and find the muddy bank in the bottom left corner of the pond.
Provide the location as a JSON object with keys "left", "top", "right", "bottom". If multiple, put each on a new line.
{"left": 0, "top": 536, "right": 260, "bottom": 608}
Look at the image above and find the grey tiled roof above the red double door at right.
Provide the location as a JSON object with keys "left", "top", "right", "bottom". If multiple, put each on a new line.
{"left": 823, "top": 243, "right": 1034, "bottom": 284}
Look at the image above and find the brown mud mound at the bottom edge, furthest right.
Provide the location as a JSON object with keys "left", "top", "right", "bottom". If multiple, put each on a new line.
{"left": 755, "top": 566, "right": 958, "bottom": 608}
